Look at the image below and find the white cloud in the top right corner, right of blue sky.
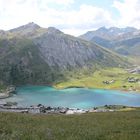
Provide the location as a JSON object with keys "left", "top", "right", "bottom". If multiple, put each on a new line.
{"left": 113, "top": 0, "right": 140, "bottom": 28}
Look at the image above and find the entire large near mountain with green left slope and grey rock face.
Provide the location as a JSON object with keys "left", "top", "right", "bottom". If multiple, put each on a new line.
{"left": 0, "top": 23, "right": 127, "bottom": 85}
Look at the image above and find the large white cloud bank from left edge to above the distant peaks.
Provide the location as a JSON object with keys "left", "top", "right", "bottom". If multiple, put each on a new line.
{"left": 0, "top": 0, "right": 114, "bottom": 35}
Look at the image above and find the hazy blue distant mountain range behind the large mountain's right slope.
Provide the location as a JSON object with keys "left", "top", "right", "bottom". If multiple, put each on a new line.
{"left": 80, "top": 27, "right": 140, "bottom": 56}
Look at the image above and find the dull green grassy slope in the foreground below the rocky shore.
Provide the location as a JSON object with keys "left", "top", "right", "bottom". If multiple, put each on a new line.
{"left": 0, "top": 109, "right": 140, "bottom": 140}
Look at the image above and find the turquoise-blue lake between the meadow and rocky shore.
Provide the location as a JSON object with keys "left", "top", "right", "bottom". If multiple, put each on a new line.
{"left": 3, "top": 86, "right": 140, "bottom": 109}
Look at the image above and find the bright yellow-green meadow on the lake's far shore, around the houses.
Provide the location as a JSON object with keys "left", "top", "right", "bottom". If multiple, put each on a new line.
{"left": 54, "top": 68, "right": 140, "bottom": 90}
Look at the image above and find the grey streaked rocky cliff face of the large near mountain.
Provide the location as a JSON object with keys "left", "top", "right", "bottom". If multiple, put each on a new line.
{"left": 34, "top": 32, "right": 118, "bottom": 68}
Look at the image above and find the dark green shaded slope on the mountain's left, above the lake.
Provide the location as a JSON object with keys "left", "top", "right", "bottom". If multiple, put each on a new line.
{"left": 0, "top": 38, "right": 62, "bottom": 85}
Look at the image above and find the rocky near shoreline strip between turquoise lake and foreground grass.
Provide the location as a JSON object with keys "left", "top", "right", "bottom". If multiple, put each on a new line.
{"left": 0, "top": 102, "right": 139, "bottom": 115}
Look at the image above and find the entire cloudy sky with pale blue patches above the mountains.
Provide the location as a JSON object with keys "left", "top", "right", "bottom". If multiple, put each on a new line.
{"left": 0, "top": 0, "right": 140, "bottom": 36}
